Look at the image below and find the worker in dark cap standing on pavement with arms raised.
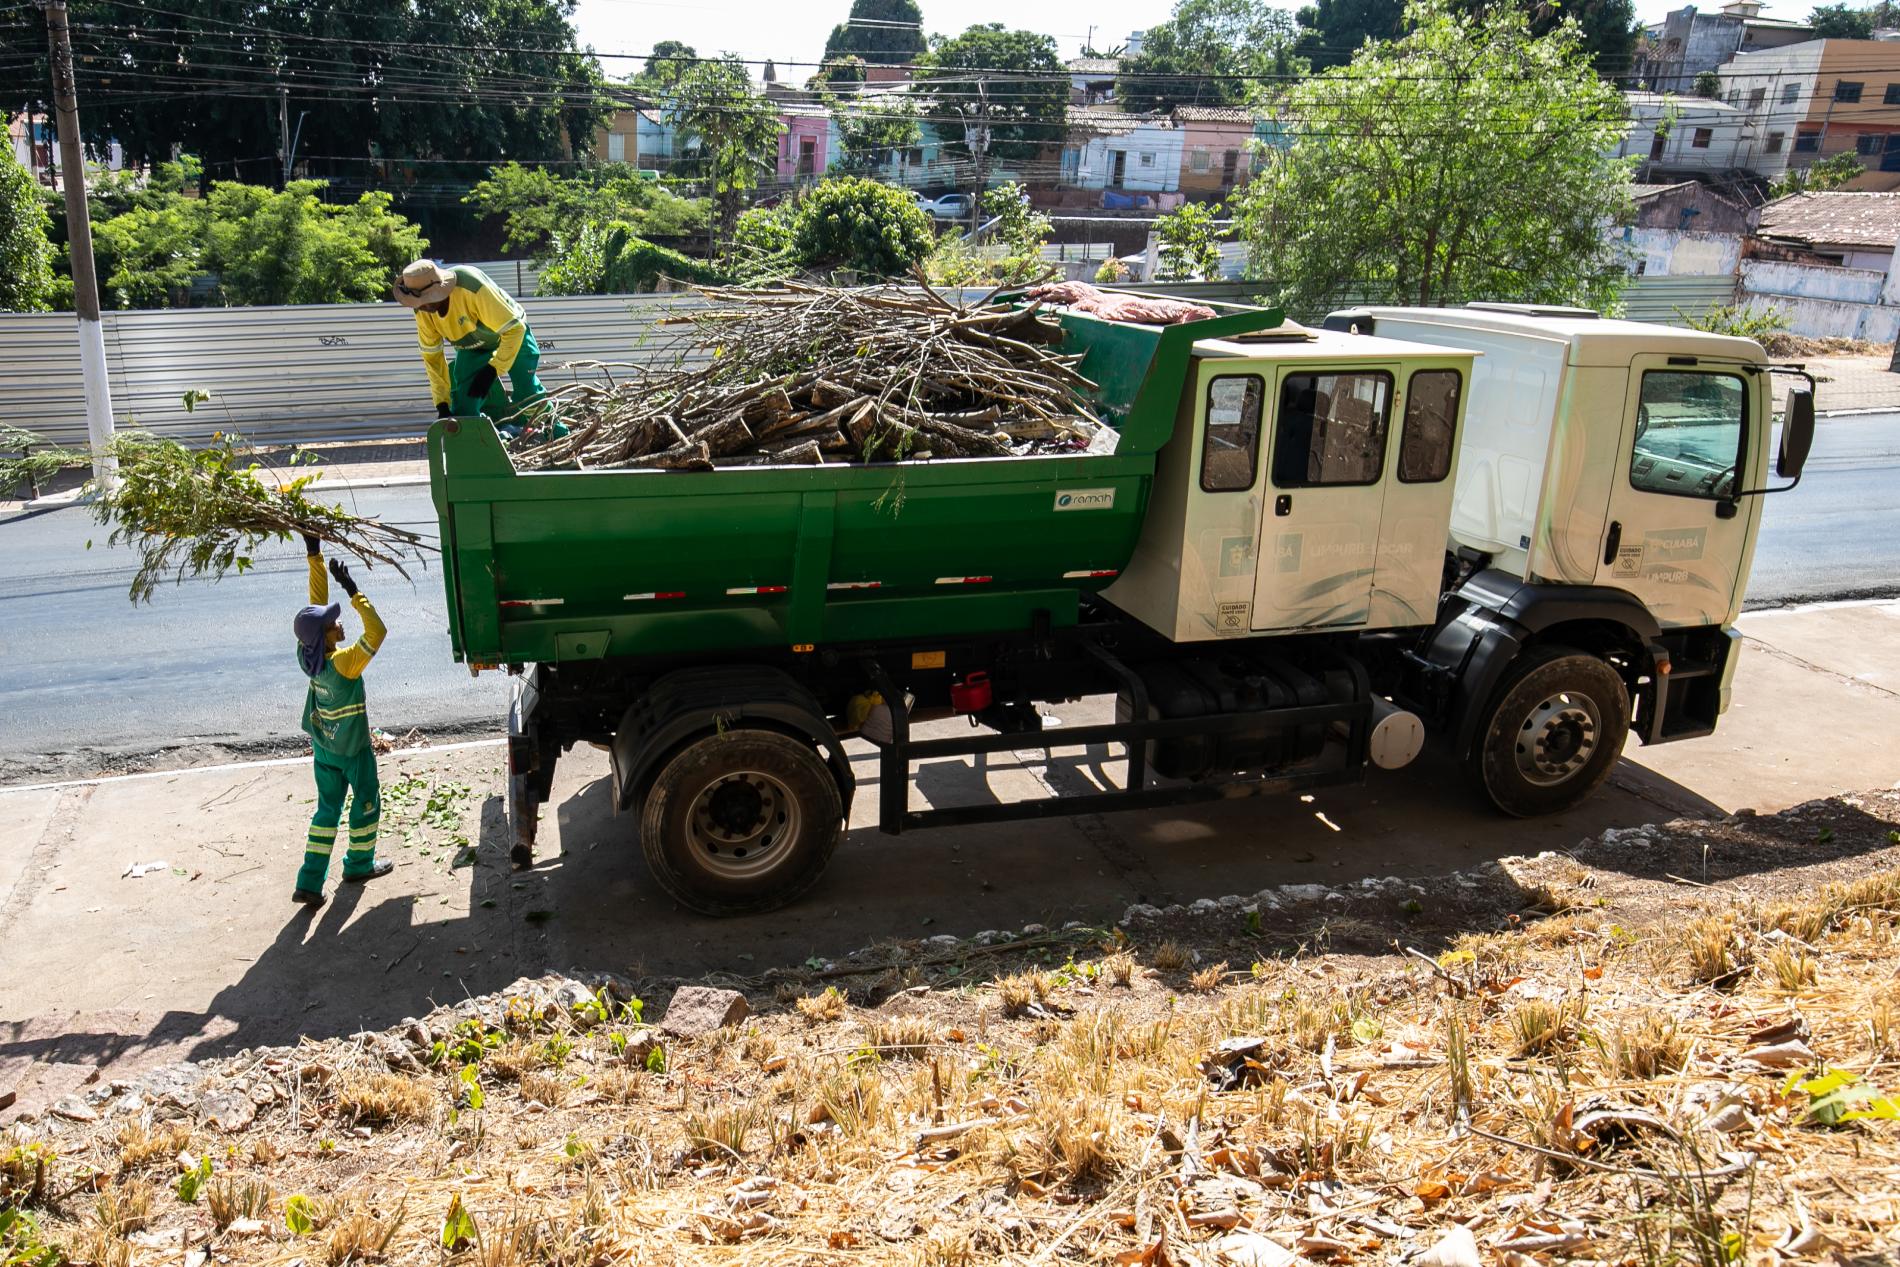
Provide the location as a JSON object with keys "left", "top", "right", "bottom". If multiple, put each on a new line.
{"left": 291, "top": 536, "right": 395, "bottom": 906}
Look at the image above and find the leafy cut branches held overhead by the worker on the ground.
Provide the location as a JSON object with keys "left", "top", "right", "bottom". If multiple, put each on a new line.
{"left": 93, "top": 431, "right": 435, "bottom": 602}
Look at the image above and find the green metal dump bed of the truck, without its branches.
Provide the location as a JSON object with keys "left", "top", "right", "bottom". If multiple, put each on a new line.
{"left": 429, "top": 308, "right": 1281, "bottom": 665}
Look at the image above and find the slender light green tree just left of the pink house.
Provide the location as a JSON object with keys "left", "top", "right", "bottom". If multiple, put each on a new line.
{"left": 665, "top": 53, "right": 785, "bottom": 245}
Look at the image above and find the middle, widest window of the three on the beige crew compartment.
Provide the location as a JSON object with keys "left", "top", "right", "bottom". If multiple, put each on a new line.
{"left": 1273, "top": 370, "right": 1393, "bottom": 488}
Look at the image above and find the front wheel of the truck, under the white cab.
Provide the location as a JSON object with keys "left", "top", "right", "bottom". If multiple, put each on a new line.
{"left": 1467, "top": 646, "right": 1630, "bottom": 819}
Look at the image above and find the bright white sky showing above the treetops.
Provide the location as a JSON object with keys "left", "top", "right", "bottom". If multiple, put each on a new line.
{"left": 576, "top": 0, "right": 1813, "bottom": 80}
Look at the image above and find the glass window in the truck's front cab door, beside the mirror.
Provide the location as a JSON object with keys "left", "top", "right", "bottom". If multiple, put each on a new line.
{"left": 1630, "top": 370, "right": 1748, "bottom": 500}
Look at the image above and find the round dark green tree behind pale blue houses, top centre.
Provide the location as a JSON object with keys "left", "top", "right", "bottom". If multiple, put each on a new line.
{"left": 920, "top": 23, "right": 1070, "bottom": 160}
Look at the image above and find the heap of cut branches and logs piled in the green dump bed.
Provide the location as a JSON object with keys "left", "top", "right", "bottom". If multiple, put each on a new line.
{"left": 515, "top": 283, "right": 1112, "bottom": 471}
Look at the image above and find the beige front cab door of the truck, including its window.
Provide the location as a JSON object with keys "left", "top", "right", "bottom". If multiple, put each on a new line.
{"left": 1596, "top": 355, "right": 1767, "bottom": 627}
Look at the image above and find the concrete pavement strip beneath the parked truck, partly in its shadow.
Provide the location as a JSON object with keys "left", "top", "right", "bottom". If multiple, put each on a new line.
{"left": 0, "top": 602, "right": 1900, "bottom": 1119}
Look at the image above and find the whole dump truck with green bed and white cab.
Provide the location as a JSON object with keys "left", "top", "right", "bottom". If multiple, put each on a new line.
{"left": 429, "top": 294, "right": 1813, "bottom": 914}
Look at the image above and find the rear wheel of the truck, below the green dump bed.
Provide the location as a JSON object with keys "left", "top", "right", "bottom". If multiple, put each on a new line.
{"left": 640, "top": 729, "right": 844, "bottom": 916}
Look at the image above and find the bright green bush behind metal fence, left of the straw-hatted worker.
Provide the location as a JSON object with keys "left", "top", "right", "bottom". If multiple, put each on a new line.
{"left": 203, "top": 180, "right": 429, "bottom": 304}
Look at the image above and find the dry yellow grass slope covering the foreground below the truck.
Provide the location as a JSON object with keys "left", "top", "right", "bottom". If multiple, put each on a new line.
{"left": 22, "top": 858, "right": 1900, "bottom": 1267}
